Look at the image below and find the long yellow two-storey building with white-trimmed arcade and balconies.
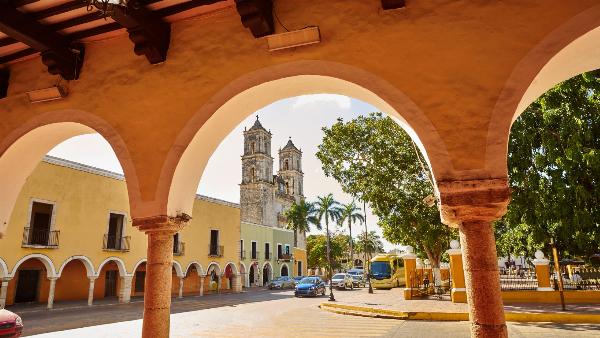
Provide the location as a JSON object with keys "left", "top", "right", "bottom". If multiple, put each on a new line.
{"left": 0, "top": 156, "right": 241, "bottom": 308}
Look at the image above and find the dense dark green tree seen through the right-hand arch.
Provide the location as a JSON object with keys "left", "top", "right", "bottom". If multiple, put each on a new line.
{"left": 496, "top": 70, "right": 600, "bottom": 256}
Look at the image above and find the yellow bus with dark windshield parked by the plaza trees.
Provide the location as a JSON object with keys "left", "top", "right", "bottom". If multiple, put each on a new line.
{"left": 369, "top": 254, "right": 406, "bottom": 289}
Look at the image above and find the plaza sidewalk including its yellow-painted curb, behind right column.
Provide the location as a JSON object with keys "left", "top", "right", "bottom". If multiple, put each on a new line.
{"left": 320, "top": 288, "right": 600, "bottom": 323}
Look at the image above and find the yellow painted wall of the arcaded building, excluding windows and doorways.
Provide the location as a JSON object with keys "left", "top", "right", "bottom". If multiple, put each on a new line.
{"left": 0, "top": 161, "right": 240, "bottom": 305}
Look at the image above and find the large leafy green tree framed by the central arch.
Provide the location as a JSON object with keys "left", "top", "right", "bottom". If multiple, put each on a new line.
{"left": 317, "top": 113, "right": 452, "bottom": 268}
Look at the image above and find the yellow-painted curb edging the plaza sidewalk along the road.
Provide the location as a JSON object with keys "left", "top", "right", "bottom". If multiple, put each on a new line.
{"left": 319, "top": 303, "right": 600, "bottom": 324}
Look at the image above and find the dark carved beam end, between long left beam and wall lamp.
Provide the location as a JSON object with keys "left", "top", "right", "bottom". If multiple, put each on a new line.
{"left": 111, "top": 7, "right": 171, "bottom": 64}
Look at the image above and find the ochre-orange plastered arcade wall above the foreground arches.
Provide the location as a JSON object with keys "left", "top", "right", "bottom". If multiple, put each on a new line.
{"left": 0, "top": 0, "right": 600, "bottom": 222}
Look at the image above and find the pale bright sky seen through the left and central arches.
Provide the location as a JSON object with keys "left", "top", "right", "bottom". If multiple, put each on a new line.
{"left": 48, "top": 94, "right": 400, "bottom": 250}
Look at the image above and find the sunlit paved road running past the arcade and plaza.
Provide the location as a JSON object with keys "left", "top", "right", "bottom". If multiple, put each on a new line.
{"left": 14, "top": 290, "right": 600, "bottom": 338}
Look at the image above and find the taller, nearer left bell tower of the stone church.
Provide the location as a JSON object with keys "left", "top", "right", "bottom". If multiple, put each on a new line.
{"left": 240, "top": 116, "right": 277, "bottom": 226}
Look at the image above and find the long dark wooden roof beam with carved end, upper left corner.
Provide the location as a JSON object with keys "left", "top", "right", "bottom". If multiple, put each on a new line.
{"left": 0, "top": 2, "right": 84, "bottom": 80}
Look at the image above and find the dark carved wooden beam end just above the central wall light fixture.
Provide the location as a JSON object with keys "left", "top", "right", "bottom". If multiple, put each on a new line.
{"left": 235, "top": 0, "right": 275, "bottom": 38}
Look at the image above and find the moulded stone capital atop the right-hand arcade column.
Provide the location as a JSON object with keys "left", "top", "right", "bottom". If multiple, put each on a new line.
{"left": 437, "top": 178, "right": 510, "bottom": 228}
